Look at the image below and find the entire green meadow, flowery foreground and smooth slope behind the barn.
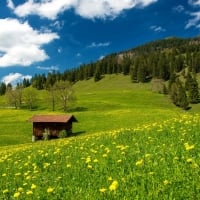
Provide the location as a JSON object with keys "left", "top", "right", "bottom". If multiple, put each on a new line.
{"left": 0, "top": 75, "right": 200, "bottom": 200}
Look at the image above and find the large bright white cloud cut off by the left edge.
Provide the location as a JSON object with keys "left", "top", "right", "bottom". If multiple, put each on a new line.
{"left": 0, "top": 18, "right": 59, "bottom": 67}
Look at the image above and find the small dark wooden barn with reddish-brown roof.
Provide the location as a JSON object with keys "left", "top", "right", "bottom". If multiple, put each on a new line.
{"left": 30, "top": 115, "right": 78, "bottom": 141}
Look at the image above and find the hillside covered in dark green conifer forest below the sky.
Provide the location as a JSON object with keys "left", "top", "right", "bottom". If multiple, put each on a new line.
{"left": 0, "top": 37, "right": 200, "bottom": 109}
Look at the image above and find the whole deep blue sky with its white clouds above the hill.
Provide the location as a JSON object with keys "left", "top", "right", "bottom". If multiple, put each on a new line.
{"left": 0, "top": 0, "right": 200, "bottom": 83}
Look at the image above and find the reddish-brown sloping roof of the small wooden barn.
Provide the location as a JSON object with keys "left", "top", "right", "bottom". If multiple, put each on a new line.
{"left": 30, "top": 115, "right": 78, "bottom": 123}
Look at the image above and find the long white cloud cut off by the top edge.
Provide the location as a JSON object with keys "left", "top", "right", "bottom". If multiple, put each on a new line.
{"left": 7, "top": 0, "right": 158, "bottom": 20}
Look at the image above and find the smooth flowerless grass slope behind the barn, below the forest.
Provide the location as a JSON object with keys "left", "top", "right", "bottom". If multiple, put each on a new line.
{"left": 0, "top": 75, "right": 182, "bottom": 146}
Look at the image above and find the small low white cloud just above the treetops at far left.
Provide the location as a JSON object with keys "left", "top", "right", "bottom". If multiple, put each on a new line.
{"left": 2, "top": 73, "right": 32, "bottom": 85}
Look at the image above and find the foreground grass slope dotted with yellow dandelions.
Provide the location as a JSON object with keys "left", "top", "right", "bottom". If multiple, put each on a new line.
{"left": 0, "top": 115, "right": 200, "bottom": 200}
